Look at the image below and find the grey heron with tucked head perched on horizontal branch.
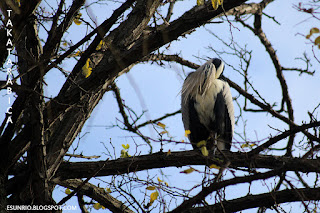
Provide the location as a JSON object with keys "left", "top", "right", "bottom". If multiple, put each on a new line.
{"left": 181, "top": 58, "right": 234, "bottom": 150}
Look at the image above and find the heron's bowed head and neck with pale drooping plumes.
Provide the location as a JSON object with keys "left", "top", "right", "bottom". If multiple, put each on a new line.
{"left": 181, "top": 58, "right": 224, "bottom": 102}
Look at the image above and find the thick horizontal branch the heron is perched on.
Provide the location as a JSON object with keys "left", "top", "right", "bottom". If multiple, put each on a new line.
{"left": 50, "top": 151, "right": 320, "bottom": 179}
